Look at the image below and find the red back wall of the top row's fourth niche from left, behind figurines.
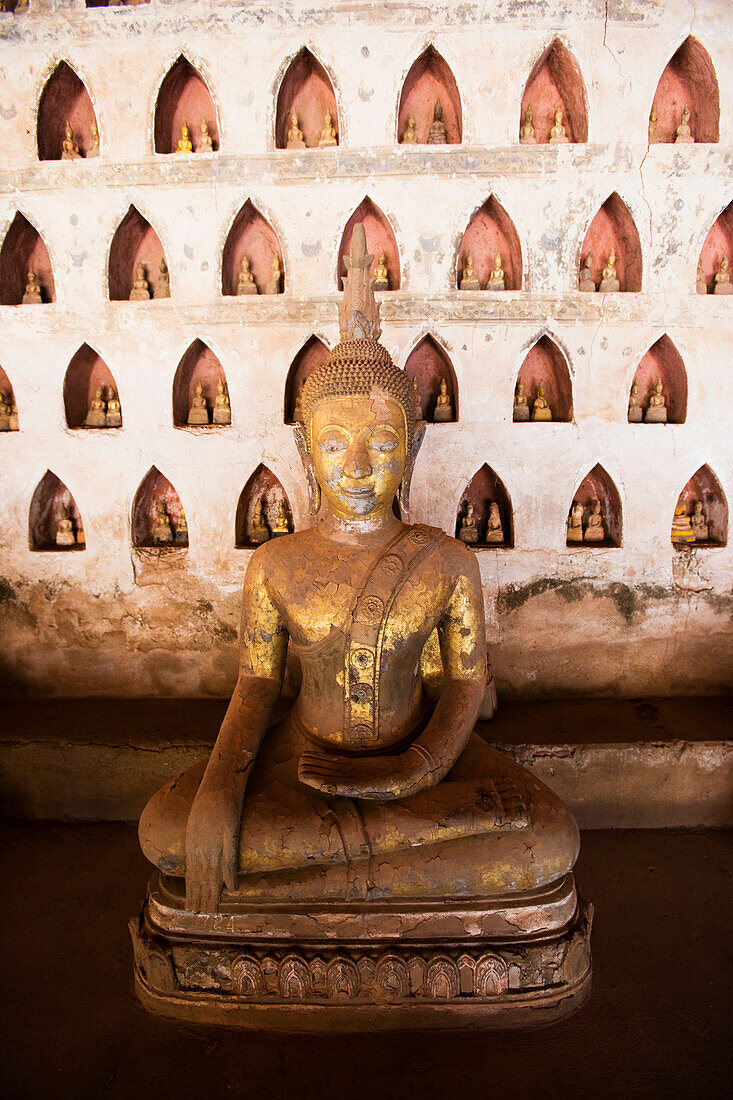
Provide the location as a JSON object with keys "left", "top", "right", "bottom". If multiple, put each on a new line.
{"left": 397, "top": 46, "right": 463, "bottom": 145}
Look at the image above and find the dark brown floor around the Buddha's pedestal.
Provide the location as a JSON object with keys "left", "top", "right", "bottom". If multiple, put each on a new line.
{"left": 0, "top": 822, "right": 733, "bottom": 1100}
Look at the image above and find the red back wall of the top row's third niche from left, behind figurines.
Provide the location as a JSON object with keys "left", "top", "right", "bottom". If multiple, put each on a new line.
{"left": 275, "top": 46, "right": 341, "bottom": 149}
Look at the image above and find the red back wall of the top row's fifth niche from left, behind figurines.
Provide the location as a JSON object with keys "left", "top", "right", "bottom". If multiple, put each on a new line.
{"left": 519, "top": 39, "right": 588, "bottom": 145}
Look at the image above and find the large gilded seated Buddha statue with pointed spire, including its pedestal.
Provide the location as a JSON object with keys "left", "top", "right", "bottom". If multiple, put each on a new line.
{"left": 131, "top": 224, "right": 590, "bottom": 1027}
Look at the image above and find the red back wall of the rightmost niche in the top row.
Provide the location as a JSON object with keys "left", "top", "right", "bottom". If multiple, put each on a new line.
{"left": 653, "top": 35, "right": 720, "bottom": 142}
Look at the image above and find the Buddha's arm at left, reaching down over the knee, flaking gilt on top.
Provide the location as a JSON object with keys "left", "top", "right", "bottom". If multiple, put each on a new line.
{"left": 186, "top": 547, "right": 287, "bottom": 912}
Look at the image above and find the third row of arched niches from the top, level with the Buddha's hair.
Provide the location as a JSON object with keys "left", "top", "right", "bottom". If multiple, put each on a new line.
{"left": 0, "top": 333, "right": 688, "bottom": 431}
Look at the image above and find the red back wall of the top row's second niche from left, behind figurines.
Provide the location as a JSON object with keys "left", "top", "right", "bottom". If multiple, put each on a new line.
{"left": 154, "top": 54, "right": 219, "bottom": 153}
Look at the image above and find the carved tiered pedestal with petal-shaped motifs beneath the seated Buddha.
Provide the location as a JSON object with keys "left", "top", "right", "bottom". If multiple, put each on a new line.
{"left": 130, "top": 876, "right": 592, "bottom": 1032}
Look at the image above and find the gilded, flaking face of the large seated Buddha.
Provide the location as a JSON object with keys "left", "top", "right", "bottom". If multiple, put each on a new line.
{"left": 310, "top": 393, "right": 407, "bottom": 520}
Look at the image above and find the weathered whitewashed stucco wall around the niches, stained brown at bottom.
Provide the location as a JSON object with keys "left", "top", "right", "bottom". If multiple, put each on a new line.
{"left": 0, "top": 0, "right": 733, "bottom": 695}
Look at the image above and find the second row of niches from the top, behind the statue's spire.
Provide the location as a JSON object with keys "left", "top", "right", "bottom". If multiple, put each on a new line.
{"left": 5, "top": 191, "right": 733, "bottom": 306}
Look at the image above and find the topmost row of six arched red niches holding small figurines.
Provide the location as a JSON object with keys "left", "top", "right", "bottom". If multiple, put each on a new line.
{"left": 21, "top": 36, "right": 720, "bottom": 161}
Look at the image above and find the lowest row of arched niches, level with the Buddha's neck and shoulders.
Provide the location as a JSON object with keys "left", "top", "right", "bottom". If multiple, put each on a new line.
{"left": 29, "top": 463, "right": 727, "bottom": 551}
